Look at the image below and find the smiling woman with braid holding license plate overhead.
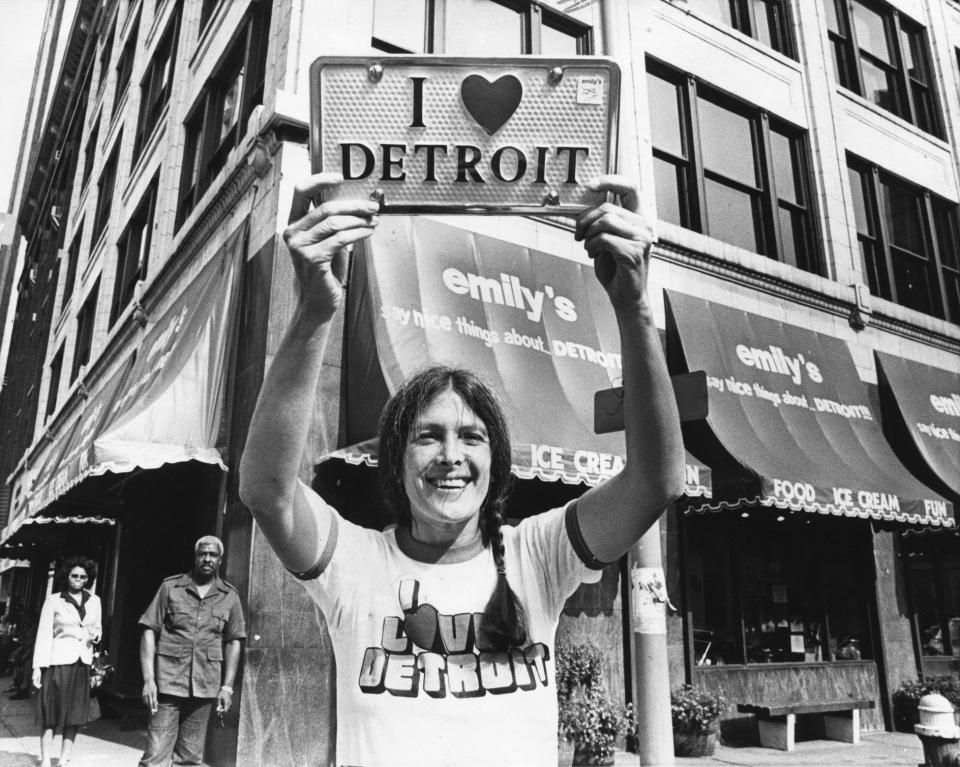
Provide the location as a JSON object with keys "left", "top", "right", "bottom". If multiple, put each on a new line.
{"left": 240, "top": 174, "right": 684, "bottom": 767}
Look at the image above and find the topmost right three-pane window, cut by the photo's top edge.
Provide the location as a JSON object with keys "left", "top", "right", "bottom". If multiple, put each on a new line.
{"left": 824, "top": 0, "right": 943, "bottom": 138}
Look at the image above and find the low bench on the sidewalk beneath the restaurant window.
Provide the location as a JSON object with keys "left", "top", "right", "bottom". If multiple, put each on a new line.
{"left": 737, "top": 698, "right": 874, "bottom": 751}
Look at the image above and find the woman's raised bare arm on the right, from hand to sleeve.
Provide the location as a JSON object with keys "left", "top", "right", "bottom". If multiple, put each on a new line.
{"left": 575, "top": 176, "right": 684, "bottom": 562}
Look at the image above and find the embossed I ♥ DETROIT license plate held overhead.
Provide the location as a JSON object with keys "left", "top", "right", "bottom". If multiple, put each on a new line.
{"left": 310, "top": 56, "right": 620, "bottom": 215}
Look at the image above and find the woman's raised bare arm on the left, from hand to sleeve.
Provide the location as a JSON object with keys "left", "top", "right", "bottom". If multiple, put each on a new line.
{"left": 240, "top": 173, "right": 378, "bottom": 572}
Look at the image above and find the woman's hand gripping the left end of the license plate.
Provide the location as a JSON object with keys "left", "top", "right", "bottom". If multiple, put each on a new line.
{"left": 283, "top": 173, "right": 380, "bottom": 321}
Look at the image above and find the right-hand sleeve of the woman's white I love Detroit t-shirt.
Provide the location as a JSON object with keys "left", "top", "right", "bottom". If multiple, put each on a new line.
{"left": 515, "top": 501, "right": 603, "bottom": 614}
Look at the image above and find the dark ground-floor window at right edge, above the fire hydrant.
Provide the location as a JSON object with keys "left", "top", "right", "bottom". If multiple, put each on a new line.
{"left": 900, "top": 535, "right": 960, "bottom": 657}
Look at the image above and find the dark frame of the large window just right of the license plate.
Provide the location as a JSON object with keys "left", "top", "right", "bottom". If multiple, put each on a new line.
{"left": 646, "top": 57, "right": 824, "bottom": 275}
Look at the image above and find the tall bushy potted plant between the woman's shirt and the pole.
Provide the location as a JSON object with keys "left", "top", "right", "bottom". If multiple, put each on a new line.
{"left": 557, "top": 641, "right": 634, "bottom": 765}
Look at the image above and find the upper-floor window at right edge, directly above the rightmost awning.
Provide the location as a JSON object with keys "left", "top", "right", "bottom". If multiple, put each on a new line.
{"left": 848, "top": 157, "right": 960, "bottom": 322}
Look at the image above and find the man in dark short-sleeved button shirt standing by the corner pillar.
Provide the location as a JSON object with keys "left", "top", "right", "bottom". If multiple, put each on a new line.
{"left": 140, "top": 535, "right": 247, "bottom": 767}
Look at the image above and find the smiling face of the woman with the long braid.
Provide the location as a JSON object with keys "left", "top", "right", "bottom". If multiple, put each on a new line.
{"left": 403, "top": 389, "right": 491, "bottom": 543}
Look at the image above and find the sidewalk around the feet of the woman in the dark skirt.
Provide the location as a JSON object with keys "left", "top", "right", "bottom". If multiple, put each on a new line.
{"left": 0, "top": 677, "right": 147, "bottom": 767}
